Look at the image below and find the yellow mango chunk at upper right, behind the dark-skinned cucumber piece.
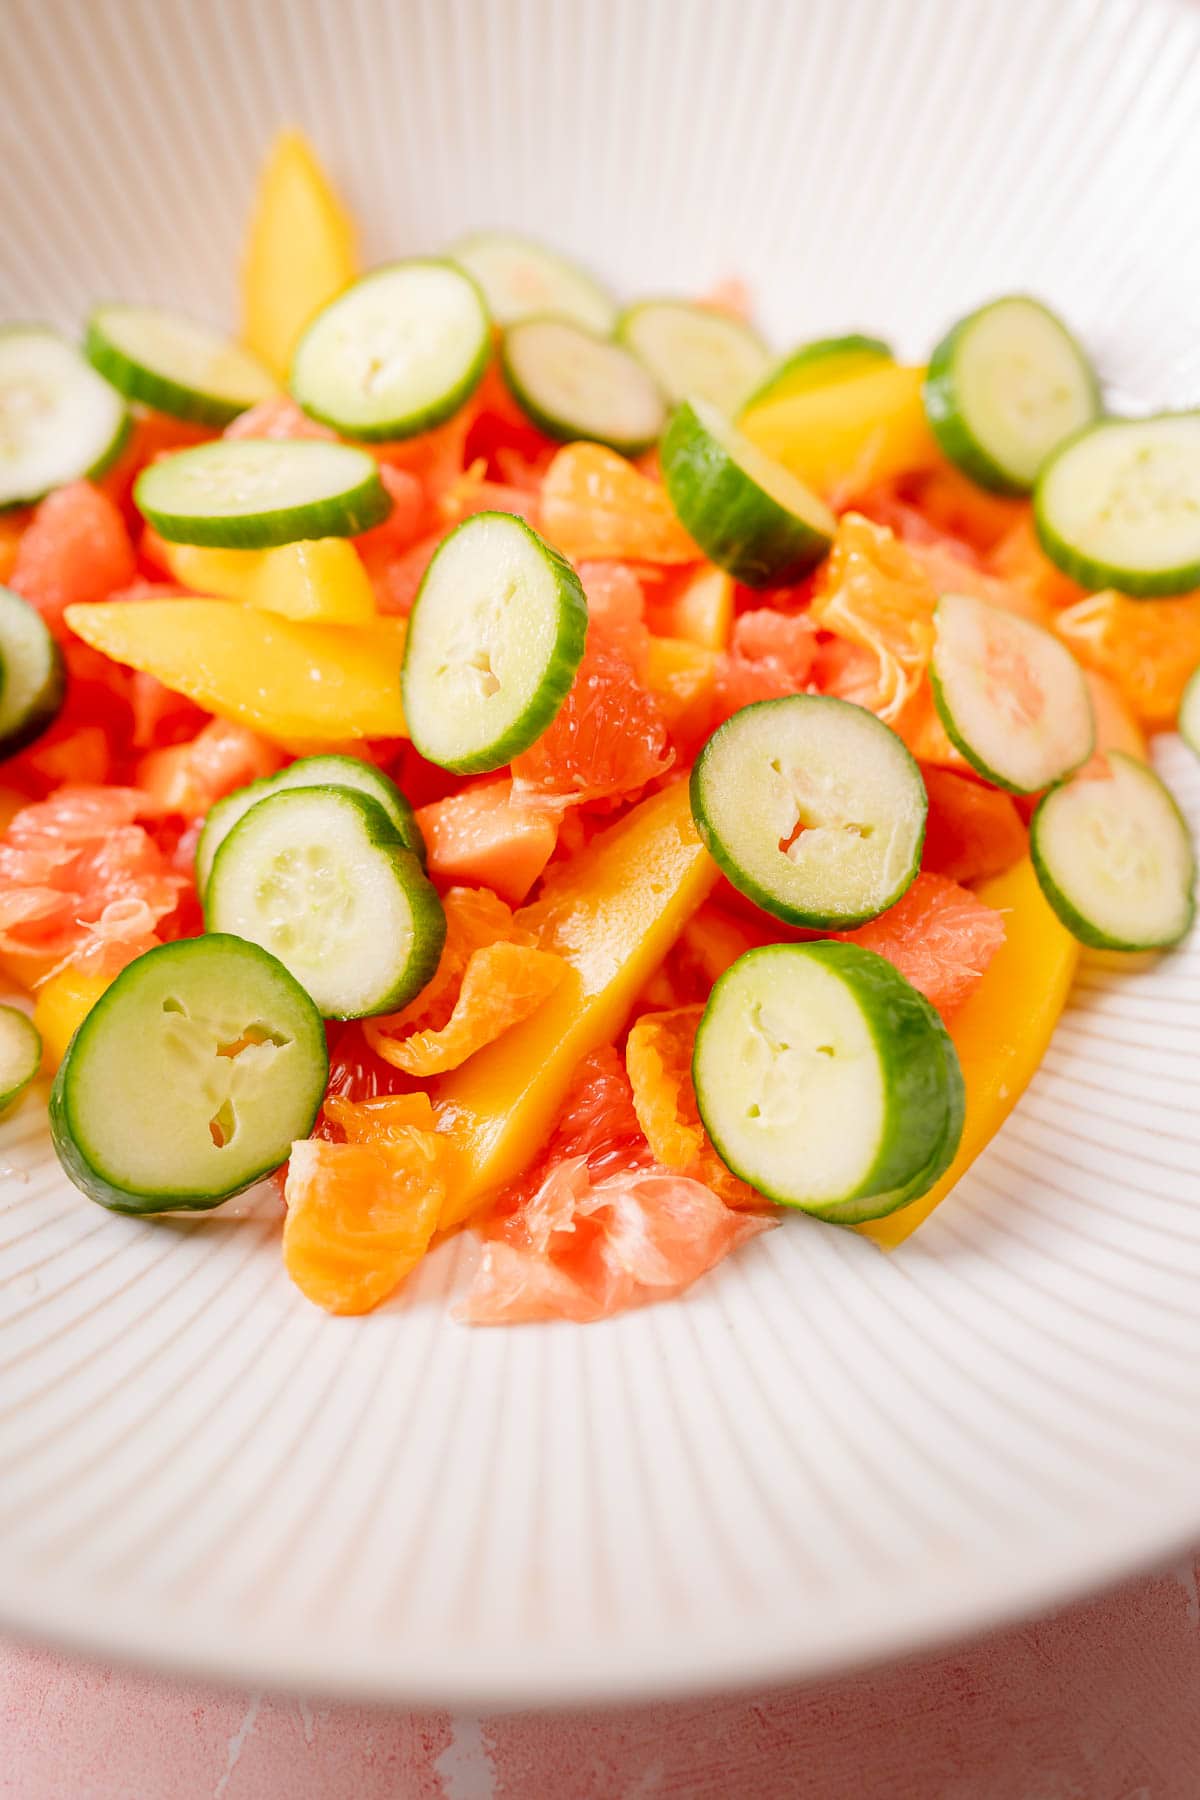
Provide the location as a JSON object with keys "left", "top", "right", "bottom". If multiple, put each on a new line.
{"left": 741, "top": 364, "right": 941, "bottom": 504}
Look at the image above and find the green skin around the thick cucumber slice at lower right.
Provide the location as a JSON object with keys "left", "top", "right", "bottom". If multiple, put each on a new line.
{"left": 691, "top": 940, "right": 966, "bottom": 1226}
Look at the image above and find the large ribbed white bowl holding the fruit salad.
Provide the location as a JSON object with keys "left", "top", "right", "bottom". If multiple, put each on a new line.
{"left": 0, "top": 0, "right": 1200, "bottom": 1703}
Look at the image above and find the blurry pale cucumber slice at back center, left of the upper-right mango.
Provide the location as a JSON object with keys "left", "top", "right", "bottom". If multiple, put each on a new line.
{"left": 617, "top": 301, "right": 770, "bottom": 412}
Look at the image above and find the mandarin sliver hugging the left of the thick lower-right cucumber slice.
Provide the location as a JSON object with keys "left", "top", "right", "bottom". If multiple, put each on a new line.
{"left": 624, "top": 1006, "right": 763, "bottom": 1206}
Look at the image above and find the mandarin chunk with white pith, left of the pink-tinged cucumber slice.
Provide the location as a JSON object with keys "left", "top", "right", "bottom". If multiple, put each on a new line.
{"left": 811, "top": 513, "right": 937, "bottom": 725}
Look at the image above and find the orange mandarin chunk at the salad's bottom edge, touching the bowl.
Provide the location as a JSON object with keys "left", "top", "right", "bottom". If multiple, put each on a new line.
{"left": 282, "top": 1125, "right": 446, "bottom": 1312}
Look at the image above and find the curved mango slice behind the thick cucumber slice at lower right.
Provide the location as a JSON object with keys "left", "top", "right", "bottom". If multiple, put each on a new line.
{"left": 856, "top": 859, "right": 1079, "bottom": 1249}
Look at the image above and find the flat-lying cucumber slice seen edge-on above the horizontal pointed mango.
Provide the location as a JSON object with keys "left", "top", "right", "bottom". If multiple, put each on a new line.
{"left": 133, "top": 437, "right": 392, "bottom": 551}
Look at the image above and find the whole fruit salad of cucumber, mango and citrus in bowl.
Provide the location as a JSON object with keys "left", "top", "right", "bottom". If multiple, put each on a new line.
{"left": 0, "top": 133, "right": 1200, "bottom": 1325}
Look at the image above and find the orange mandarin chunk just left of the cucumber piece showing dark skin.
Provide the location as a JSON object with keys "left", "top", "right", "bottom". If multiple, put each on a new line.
{"left": 542, "top": 443, "right": 700, "bottom": 563}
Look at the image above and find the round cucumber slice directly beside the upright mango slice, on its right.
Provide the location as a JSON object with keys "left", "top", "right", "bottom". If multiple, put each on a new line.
{"left": 290, "top": 259, "right": 491, "bottom": 439}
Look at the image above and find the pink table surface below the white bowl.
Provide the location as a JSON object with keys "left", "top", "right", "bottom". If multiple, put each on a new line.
{"left": 0, "top": 1557, "right": 1200, "bottom": 1800}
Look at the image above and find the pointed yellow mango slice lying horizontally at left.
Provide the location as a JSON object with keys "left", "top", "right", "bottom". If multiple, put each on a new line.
{"left": 65, "top": 599, "right": 407, "bottom": 747}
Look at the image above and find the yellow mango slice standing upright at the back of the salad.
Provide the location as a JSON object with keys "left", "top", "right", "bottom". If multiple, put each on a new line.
{"left": 241, "top": 131, "right": 358, "bottom": 376}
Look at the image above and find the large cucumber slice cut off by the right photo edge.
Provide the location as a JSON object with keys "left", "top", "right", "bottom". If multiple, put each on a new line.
{"left": 1033, "top": 412, "right": 1200, "bottom": 598}
